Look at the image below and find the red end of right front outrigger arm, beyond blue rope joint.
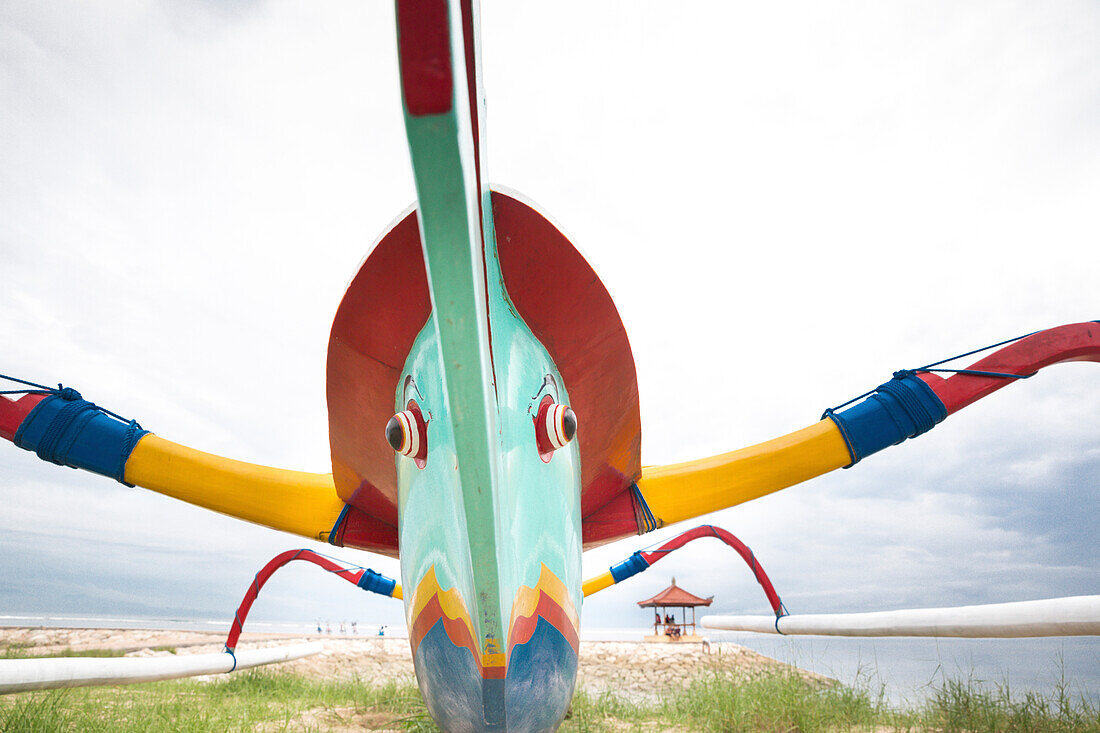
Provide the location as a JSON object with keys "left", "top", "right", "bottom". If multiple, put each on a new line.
{"left": 917, "top": 321, "right": 1100, "bottom": 415}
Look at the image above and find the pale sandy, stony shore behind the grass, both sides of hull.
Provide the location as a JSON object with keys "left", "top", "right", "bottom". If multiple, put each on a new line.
{"left": 0, "top": 627, "right": 816, "bottom": 699}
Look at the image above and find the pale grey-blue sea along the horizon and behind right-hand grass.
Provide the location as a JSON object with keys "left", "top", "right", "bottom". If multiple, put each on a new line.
{"left": 0, "top": 614, "right": 1100, "bottom": 707}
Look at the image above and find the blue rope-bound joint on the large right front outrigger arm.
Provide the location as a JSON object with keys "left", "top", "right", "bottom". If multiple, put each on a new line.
{"left": 822, "top": 370, "right": 947, "bottom": 468}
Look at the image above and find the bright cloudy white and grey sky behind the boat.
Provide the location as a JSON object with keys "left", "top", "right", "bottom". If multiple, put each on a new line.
{"left": 0, "top": 0, "right": 1100, "bottom": 691}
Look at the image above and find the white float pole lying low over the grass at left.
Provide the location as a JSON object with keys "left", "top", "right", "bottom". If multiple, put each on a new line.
{"left": 0, "top": 643, "right": 323, "bottom": 694}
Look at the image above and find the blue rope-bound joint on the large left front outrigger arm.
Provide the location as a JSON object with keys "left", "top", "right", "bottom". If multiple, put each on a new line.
{"left": 12, "top": 387, "right": 149, "bottom": 486}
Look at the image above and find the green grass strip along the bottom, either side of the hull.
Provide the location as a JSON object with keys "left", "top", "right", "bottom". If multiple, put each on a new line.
{"left": 0, "top": 670, "right": 1100, "bottom": 733}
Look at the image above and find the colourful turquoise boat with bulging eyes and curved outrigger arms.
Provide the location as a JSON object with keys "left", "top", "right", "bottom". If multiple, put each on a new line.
{"left": 0, "top": 0, "right": 1100, "bottom": 731}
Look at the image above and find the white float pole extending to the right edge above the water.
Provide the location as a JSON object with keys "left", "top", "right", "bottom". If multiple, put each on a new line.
{"left": 700, "top": 595, "right": 1100, "bottom": 638}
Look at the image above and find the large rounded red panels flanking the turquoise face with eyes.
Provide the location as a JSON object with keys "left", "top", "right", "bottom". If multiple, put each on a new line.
{"left": 327, "top": 192, "right": 641, "bottom": 555}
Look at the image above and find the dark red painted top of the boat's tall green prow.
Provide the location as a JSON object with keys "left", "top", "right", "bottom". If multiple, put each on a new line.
{"left": 397, "top": 0, "right": 454, "bottom": 117}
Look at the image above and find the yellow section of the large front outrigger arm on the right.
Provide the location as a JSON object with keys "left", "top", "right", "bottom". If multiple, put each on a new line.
{"left": 638, "top": 419, "right": 851, "bottom": 526}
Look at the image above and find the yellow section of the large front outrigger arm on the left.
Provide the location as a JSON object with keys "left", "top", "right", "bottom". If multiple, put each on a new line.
{"left": 125, "top": 434, "right": 344, "bottom": 540}
